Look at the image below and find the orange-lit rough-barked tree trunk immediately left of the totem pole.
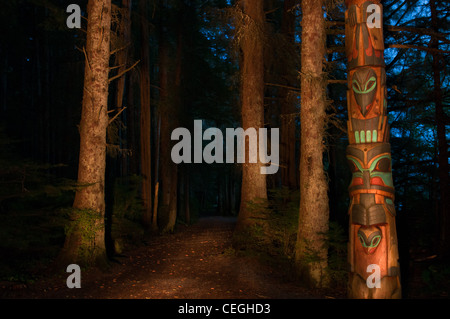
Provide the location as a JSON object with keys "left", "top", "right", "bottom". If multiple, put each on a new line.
{"left": 296, "top": 0, "right": 329, "bottom": 287}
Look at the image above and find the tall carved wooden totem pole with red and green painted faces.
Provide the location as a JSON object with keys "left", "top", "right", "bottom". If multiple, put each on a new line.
{"left": 345, "top": 0, "right": 401, "bottom": 299}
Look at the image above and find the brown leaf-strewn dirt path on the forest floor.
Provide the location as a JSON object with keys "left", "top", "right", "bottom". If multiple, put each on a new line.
{"left": 0, "top": 217, "right": 340, "bottom": 299}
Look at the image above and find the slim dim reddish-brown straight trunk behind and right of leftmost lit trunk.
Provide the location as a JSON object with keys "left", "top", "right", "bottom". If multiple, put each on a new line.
{"left": 139, "top": 0, "right": 152, "bottom": 229}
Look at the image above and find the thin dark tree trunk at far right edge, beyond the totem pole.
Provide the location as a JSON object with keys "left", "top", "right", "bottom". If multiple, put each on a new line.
{"left": 430, "top": 0, "right": 450, "bottom": 257}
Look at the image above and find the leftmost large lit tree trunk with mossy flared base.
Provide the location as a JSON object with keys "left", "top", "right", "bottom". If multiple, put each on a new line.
{"left": 59, "top": 0, "right": 111, "bottom": 266}
